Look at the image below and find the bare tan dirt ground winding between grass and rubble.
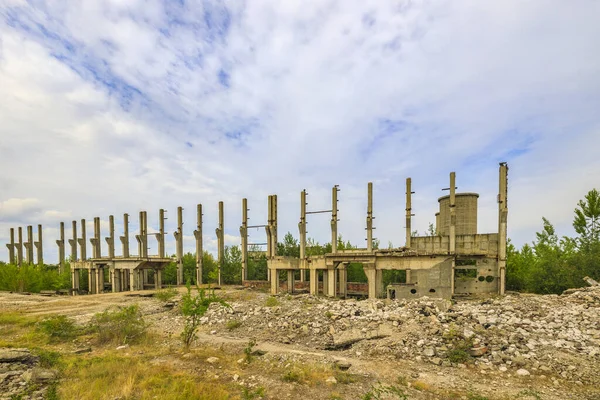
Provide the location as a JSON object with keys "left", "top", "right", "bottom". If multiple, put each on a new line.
{"left": 0, "top": 287, "right": 600, "bottom": 400}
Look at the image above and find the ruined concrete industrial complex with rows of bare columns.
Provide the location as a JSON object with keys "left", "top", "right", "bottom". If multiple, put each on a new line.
{"left": 6, "top": 163, "right": 508, "bottom": 299}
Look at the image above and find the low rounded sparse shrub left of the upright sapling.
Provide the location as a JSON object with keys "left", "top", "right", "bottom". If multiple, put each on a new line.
{"left": 90, "top": 304, "right": 147, "bottom": 345}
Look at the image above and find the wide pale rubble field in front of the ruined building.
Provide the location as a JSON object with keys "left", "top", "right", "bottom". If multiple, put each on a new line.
{"left": 202, "top": 286, "right": 600, "bottom": 383}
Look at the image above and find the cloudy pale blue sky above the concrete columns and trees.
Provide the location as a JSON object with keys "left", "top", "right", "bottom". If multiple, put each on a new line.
{"left": 0, "top": 0, "right": 600, "bottom": 263}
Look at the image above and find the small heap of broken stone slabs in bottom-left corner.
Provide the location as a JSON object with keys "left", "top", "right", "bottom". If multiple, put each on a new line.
{"left": 0, "top": 348, "right": 56, "bottom": 400}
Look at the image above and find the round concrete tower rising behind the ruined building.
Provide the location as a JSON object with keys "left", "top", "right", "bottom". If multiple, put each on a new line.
{"left": 436, "top": 193, "right": 479, "bottom": 236}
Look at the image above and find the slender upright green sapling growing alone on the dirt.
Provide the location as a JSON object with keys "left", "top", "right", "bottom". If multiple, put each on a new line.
{"left": 180, "top": 281, "right": 229, "bottom": 348}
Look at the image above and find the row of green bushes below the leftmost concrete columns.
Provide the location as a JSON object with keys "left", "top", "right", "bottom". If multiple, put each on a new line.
{"left": 0, "top": 264, "right": 71, "bottom": 293}
